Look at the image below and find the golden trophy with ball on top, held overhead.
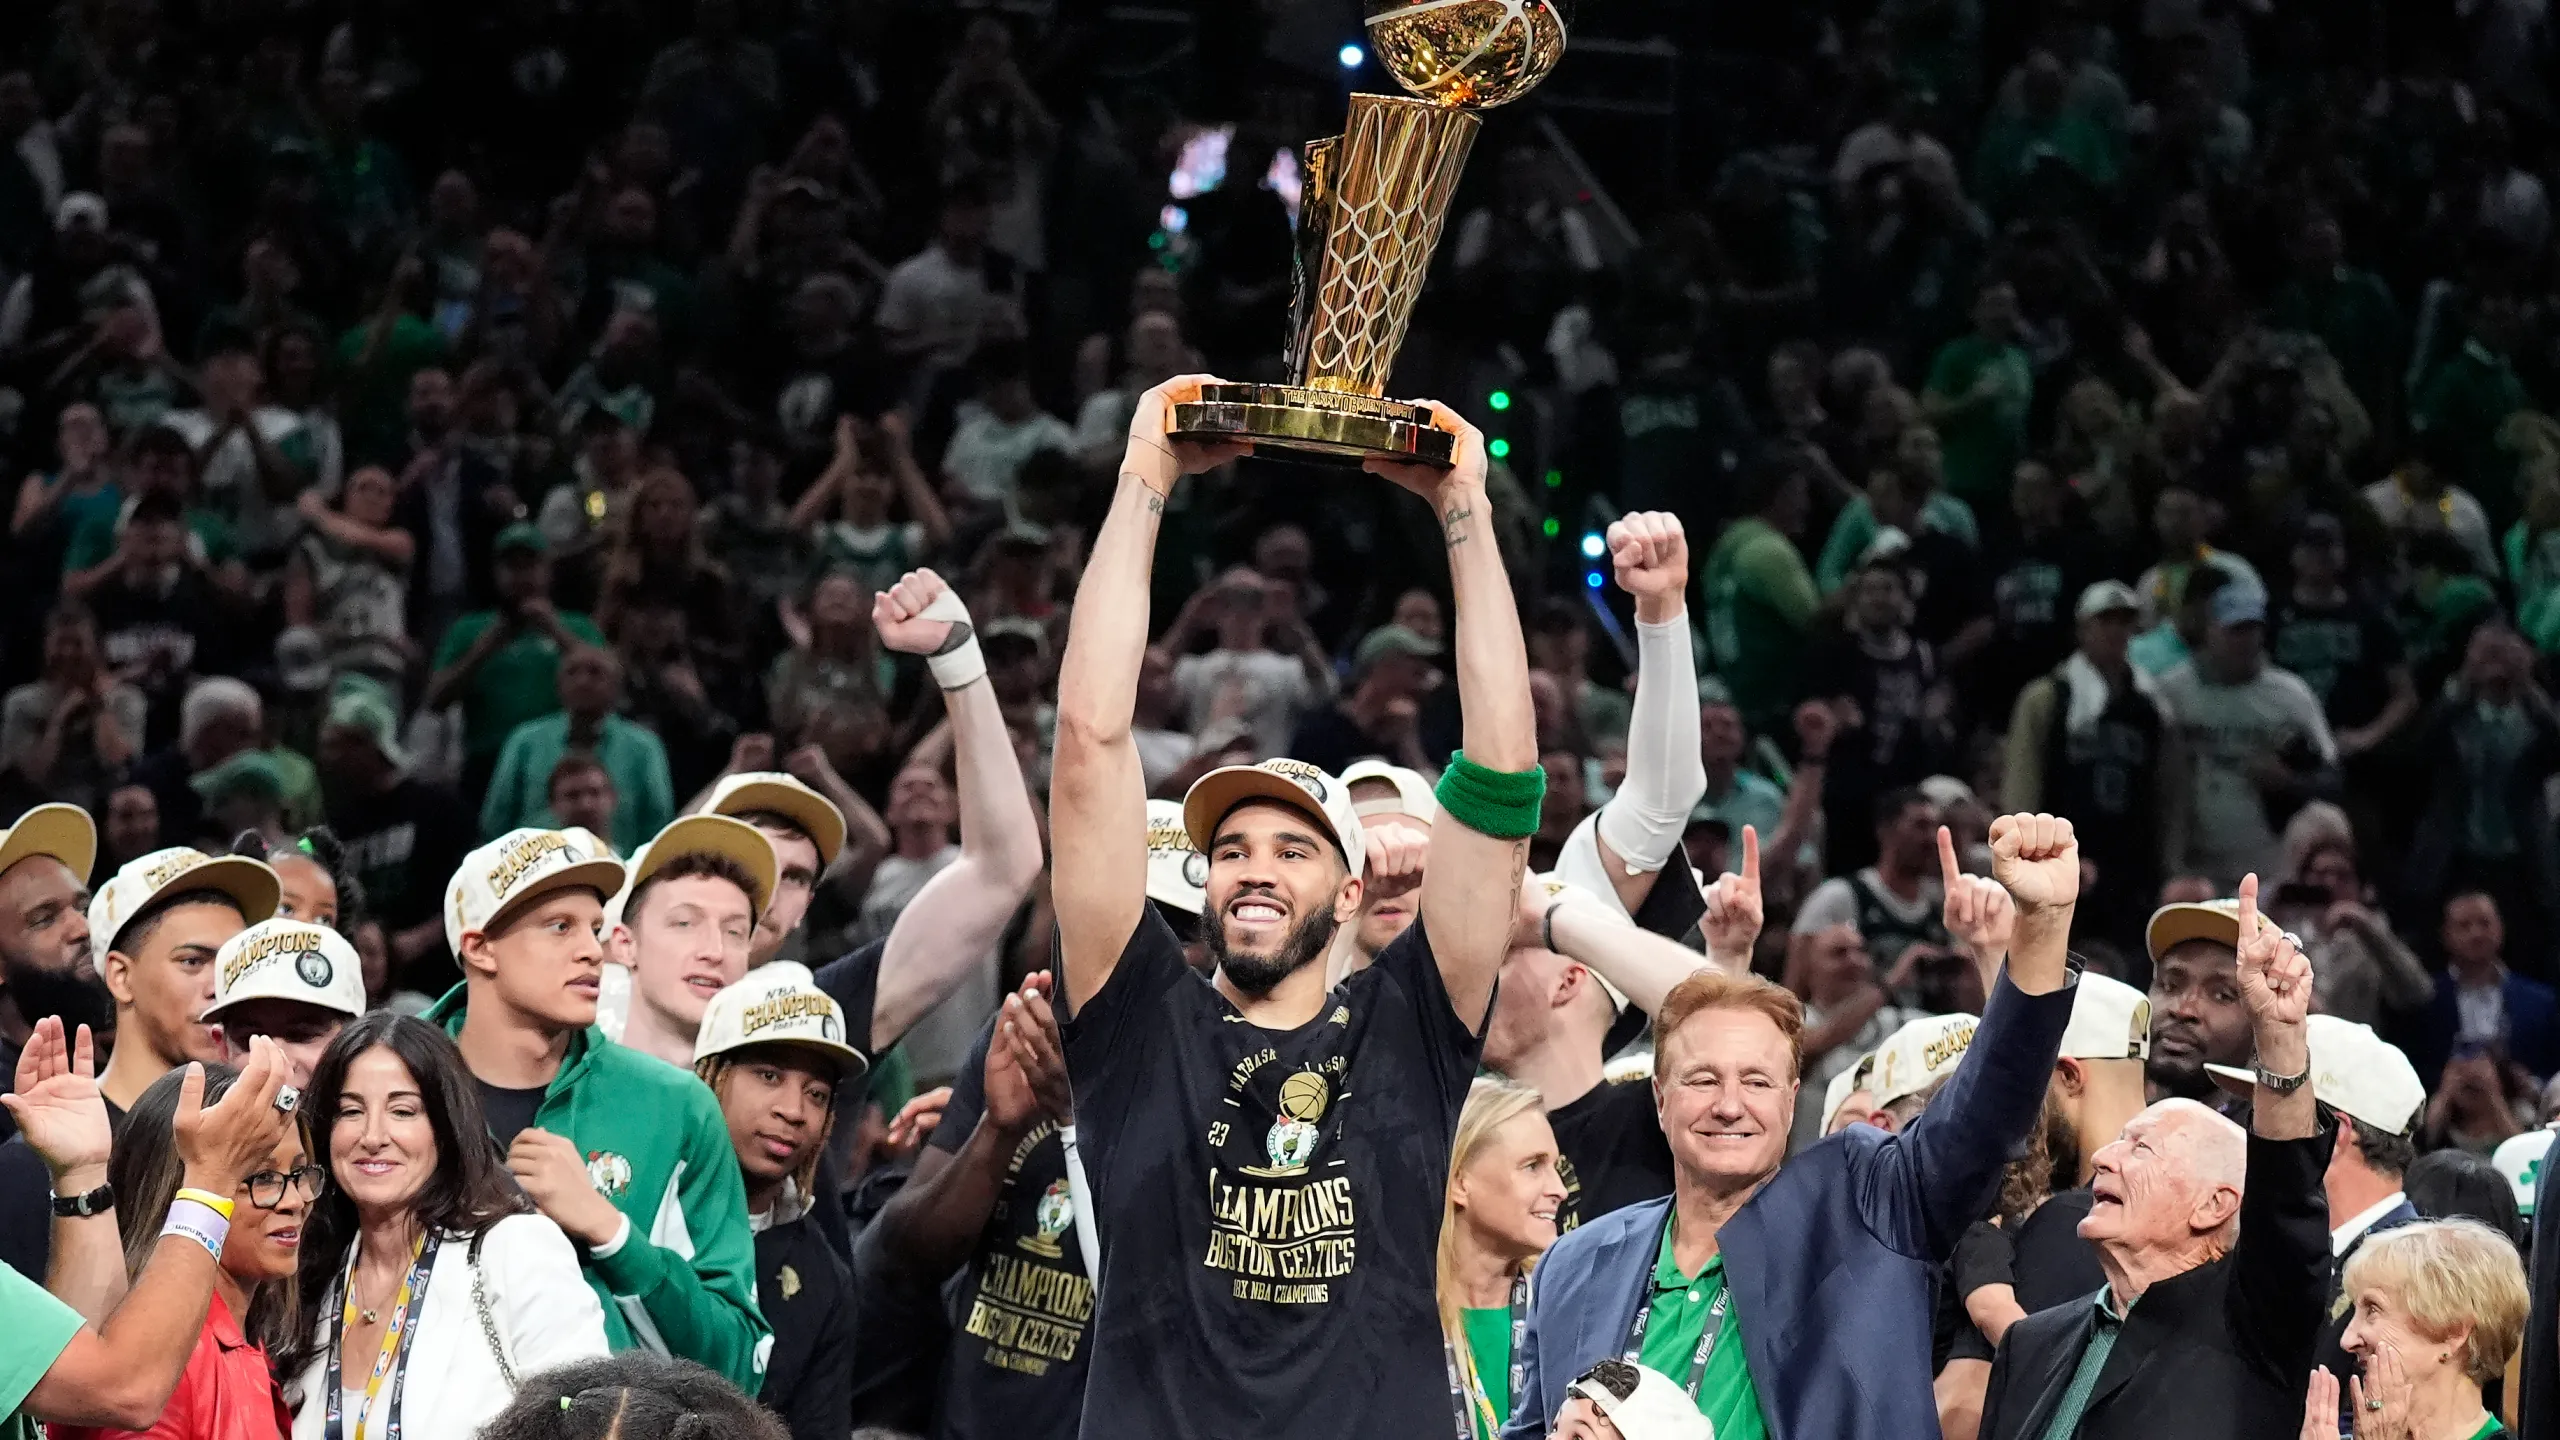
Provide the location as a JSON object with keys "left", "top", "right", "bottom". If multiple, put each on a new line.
{"left": 1172, "top": 0, "right": 1564, "bottom": 464}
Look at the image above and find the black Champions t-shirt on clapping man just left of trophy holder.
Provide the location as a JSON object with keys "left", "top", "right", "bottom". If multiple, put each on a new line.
{"left": 932, "top": 1030, "right": 1093, "bottom": 1440}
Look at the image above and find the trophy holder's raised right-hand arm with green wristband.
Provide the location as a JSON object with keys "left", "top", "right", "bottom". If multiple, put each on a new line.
{"left": 1372, "top": 405, "right": 1546, "bottom": 1030}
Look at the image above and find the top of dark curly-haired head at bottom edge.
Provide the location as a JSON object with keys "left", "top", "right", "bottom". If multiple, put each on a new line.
{"left": 481, "top": 1350, "right": 788, "bottom": 1440}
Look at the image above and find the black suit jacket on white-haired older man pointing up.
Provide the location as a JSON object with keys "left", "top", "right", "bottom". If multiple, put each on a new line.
{"left": 1979, "top": 1130, "right": 2337, "bottom": 1440}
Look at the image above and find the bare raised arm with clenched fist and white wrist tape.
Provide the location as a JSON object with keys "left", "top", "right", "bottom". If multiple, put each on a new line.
{"left": 870, "top": 569, "right": 1049, "bottom": 1053}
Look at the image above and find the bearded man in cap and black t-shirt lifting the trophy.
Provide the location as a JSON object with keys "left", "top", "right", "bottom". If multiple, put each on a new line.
{"left": 1052, "top": 377, "right": 1541, "bottom": 1440}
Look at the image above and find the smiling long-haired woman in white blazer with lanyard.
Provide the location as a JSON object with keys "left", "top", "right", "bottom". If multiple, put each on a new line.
{"left": 269, "top": 1010, "right": 607, "bottom": 1440}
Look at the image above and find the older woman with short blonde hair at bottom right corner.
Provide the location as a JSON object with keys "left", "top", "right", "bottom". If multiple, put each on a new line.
{"left": 2301, "top": 1220, "right": 2527, "bottom": 1440}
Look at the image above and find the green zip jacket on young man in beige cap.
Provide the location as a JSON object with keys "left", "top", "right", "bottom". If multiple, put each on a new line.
{"left": 425, "top": 986, "right": 773, "bottom": 1394}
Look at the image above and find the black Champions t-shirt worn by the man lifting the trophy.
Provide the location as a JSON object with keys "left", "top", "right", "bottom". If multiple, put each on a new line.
{"left": 1068, "top": 910, "right": 1482, "bottom": 1440}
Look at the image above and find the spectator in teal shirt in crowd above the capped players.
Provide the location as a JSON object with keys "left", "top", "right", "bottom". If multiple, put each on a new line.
{"left": 481, "top": 646, "right": 676, "bottom": 856}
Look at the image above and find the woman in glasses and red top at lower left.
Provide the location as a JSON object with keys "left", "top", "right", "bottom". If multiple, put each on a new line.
{"left": 54, "top": 1066, "right": 320, "bottom": 1440}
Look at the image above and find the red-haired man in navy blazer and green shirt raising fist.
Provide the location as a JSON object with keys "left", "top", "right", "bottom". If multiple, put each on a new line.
{"left": 1503, "top": 815, "right": 2079, "bottom": 1440}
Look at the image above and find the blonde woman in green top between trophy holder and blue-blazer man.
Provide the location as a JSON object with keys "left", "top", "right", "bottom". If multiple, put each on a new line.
{"left": 1439, "top": 1079, "right": 1564, "bottom": 1440}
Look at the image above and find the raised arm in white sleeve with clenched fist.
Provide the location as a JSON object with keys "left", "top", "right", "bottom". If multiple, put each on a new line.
{"left": 1592, "top": 510, "right": 1710, "bottom": 915}
